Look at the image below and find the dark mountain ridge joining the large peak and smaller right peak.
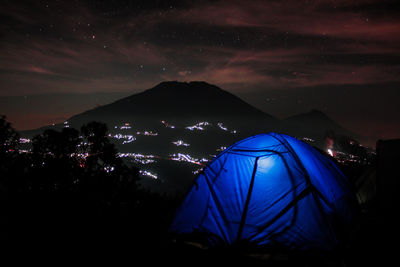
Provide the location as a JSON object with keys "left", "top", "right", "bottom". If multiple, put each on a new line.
{"left": 20, "top": 81, "right": 358, "bottom": 144}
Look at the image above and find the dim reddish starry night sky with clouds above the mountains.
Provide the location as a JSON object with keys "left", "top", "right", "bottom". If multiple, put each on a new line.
{"left": 0, "top": 0, "right": 400, "bottom": 144}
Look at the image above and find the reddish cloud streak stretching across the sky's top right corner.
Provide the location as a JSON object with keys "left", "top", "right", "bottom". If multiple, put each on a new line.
{"left": 179, "top": 1, "right": 400, "bottom": 42}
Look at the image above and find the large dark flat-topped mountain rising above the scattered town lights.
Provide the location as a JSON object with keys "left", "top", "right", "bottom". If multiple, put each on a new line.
{"left": 68, "top": 81, "right": 278, "bottom": 130}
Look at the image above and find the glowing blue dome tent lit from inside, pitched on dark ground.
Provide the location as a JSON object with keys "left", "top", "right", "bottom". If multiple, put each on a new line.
{"left": 170, "top": 133, "right": 354, "bottom": 250}
